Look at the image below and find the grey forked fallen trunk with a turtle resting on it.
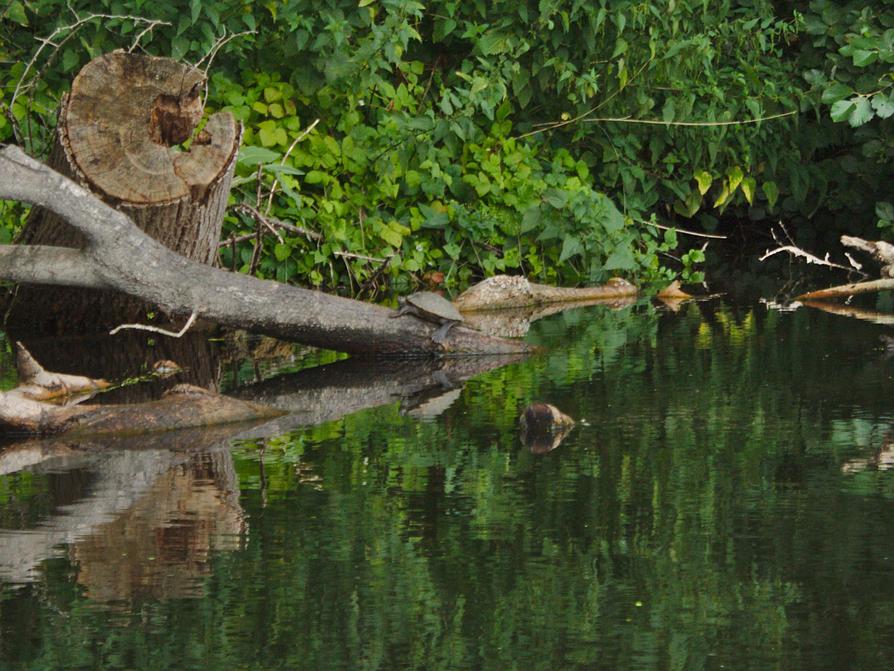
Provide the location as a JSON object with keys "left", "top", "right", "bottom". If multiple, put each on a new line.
{"left": 0, "top": 146, "right": 530, "bottom": 356}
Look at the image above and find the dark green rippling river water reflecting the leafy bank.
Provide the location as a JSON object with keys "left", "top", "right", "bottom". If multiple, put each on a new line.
{"left": 0, "top": 304, "right": 894, "bottom": 671}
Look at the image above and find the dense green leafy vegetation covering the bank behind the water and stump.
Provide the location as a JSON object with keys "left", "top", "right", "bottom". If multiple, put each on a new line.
{"left": 0, "top": 0, "right": 894, "bottom": 295}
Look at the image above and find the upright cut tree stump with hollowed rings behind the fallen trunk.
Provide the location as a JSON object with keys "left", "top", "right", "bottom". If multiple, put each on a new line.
{"left": 8, "top": 51, "right": 241, "bottom": 333}
